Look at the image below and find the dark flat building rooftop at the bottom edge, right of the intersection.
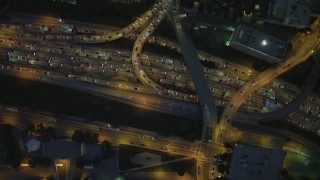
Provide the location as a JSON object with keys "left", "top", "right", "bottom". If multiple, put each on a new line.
{"left": 229, "top": 145, "right": 286, "bottom": 180}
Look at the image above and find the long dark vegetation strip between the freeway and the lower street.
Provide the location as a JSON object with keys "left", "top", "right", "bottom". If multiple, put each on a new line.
{"left": 0, "top": 75, "right": 202, "bottom": 140}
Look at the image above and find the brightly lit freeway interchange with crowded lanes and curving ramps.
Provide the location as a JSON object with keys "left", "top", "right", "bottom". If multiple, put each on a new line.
{"left": 0, "top": 1, "right": 320, "bottom": 179}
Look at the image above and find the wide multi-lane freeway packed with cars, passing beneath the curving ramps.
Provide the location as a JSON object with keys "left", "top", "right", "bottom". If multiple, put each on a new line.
{"left": 2, "top": 7, "right": 317, "bottom": 131}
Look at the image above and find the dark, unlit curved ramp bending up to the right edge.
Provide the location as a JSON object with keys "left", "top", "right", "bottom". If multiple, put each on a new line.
{"left": 235, "top": 53, "right": 320, "bottom": 121}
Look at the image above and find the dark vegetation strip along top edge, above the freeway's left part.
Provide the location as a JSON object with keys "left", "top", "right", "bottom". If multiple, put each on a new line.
{"left": 9, "top": 0, "right": 155, "bottom": 26}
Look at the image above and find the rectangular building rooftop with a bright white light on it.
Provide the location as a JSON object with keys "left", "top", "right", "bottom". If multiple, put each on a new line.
{"left": 230, "top": 25, "right": 288, "bottom": 62}
